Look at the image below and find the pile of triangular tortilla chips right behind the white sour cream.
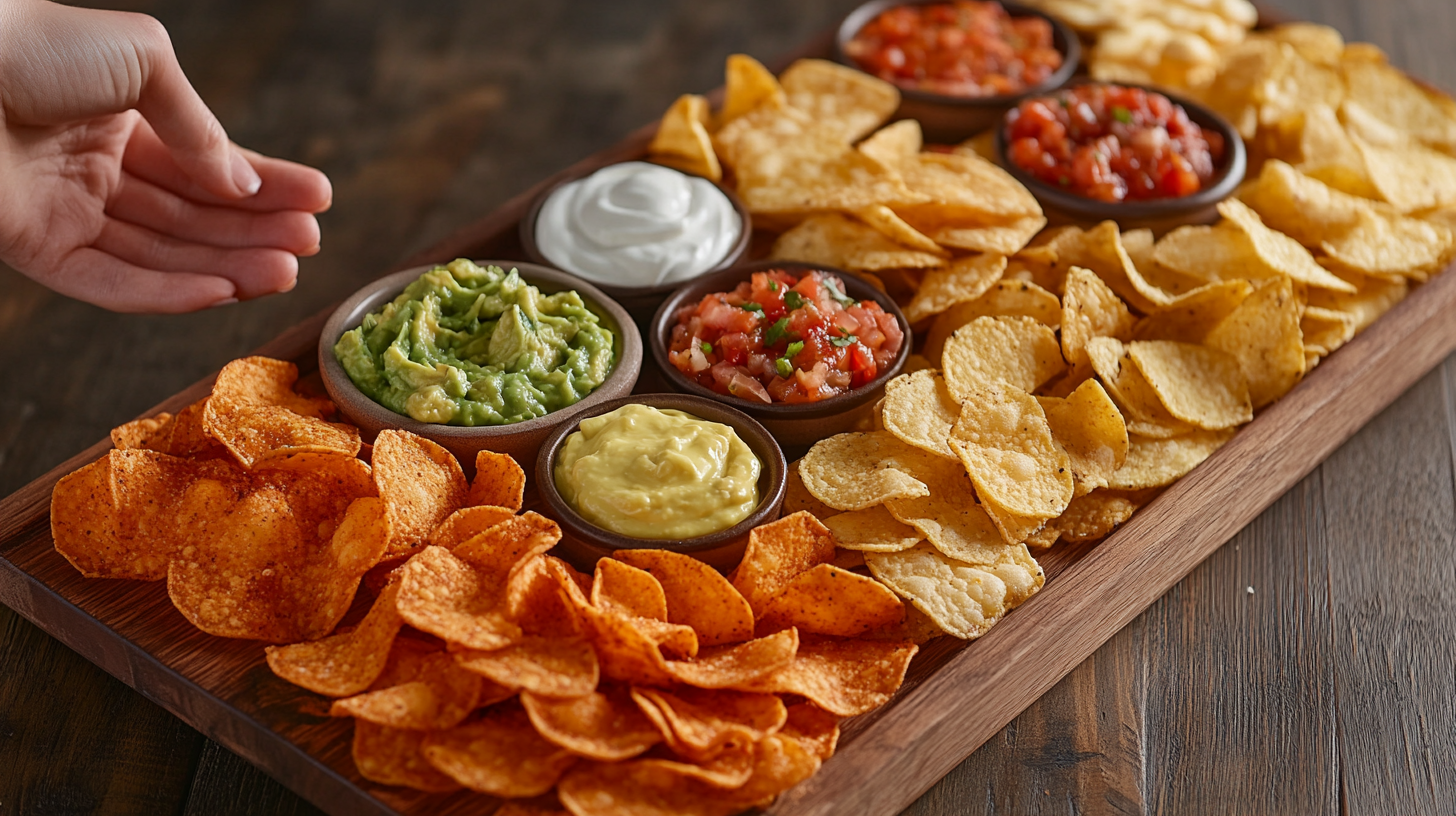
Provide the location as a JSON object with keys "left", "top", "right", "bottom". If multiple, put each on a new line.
{"left": 649, "top": 55, "right": 1047, "bottom": 289}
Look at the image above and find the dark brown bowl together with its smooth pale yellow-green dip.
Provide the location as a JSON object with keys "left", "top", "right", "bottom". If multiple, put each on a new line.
{"left": 536, "top": 393, "right": 788, "bottom": 573}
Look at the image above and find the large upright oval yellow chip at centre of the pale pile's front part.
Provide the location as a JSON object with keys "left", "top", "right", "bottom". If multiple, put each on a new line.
{"left": 951, "top": 385, "right": 1073, "bottom": 541}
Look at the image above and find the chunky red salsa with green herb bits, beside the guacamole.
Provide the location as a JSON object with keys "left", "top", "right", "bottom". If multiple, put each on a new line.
{"left": 668, "top": 270, "right": 904, "bottom": 402}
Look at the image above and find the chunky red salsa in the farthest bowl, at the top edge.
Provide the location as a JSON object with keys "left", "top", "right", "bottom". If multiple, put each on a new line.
{"left": 844, "top": 0, "right": 1061, "bottom": 98}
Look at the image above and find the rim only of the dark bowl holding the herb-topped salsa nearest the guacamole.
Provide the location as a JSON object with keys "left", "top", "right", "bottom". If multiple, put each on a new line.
{"left": 648, "top": 261, "right": 914, "bottom": 420}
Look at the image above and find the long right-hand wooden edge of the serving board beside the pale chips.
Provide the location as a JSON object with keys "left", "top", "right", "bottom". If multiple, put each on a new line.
{"left": 769, "top": 256, "right": 1456, "bottom": 816}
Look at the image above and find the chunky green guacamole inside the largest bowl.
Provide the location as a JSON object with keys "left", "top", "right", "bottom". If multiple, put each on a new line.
{"left": 333, "top": 259, "right": 616, "bottom": 425}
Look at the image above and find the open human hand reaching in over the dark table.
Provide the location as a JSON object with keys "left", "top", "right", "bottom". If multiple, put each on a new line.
{"left": 0, "top": 0, "right": 332, "bottom": 312}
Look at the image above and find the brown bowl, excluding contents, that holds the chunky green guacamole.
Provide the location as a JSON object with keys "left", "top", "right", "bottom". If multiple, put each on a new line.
{"left": 319, "top": 261, "right": 642, "bottom": 472}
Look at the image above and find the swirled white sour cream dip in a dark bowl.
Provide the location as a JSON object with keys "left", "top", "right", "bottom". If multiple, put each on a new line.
{"left": 536, "top": 162, "right": 743, "bottom": 286}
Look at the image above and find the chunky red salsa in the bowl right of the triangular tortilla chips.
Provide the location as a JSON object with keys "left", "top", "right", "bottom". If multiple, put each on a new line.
{"left": 1008, "top": 85, "right": 1224, "bottom": 201}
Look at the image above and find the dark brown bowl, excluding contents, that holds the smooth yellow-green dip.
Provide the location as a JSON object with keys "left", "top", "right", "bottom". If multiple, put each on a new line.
{"left": 536, "top": 393, "right": 788, "bottom": 573}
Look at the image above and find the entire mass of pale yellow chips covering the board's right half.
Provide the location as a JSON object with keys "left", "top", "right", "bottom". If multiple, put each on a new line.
{"left": 654, "top": 34, "right": 1456, "bottom": 638}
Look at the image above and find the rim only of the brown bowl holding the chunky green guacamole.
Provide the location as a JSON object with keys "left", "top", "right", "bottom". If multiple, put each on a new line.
{"left": 319, "top": 261, "right": 642, "bottom": 440}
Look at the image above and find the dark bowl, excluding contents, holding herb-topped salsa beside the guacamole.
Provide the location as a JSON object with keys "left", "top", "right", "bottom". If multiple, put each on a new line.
{"left": 648, "top": 261, "right": 913, "bottom": 452}
